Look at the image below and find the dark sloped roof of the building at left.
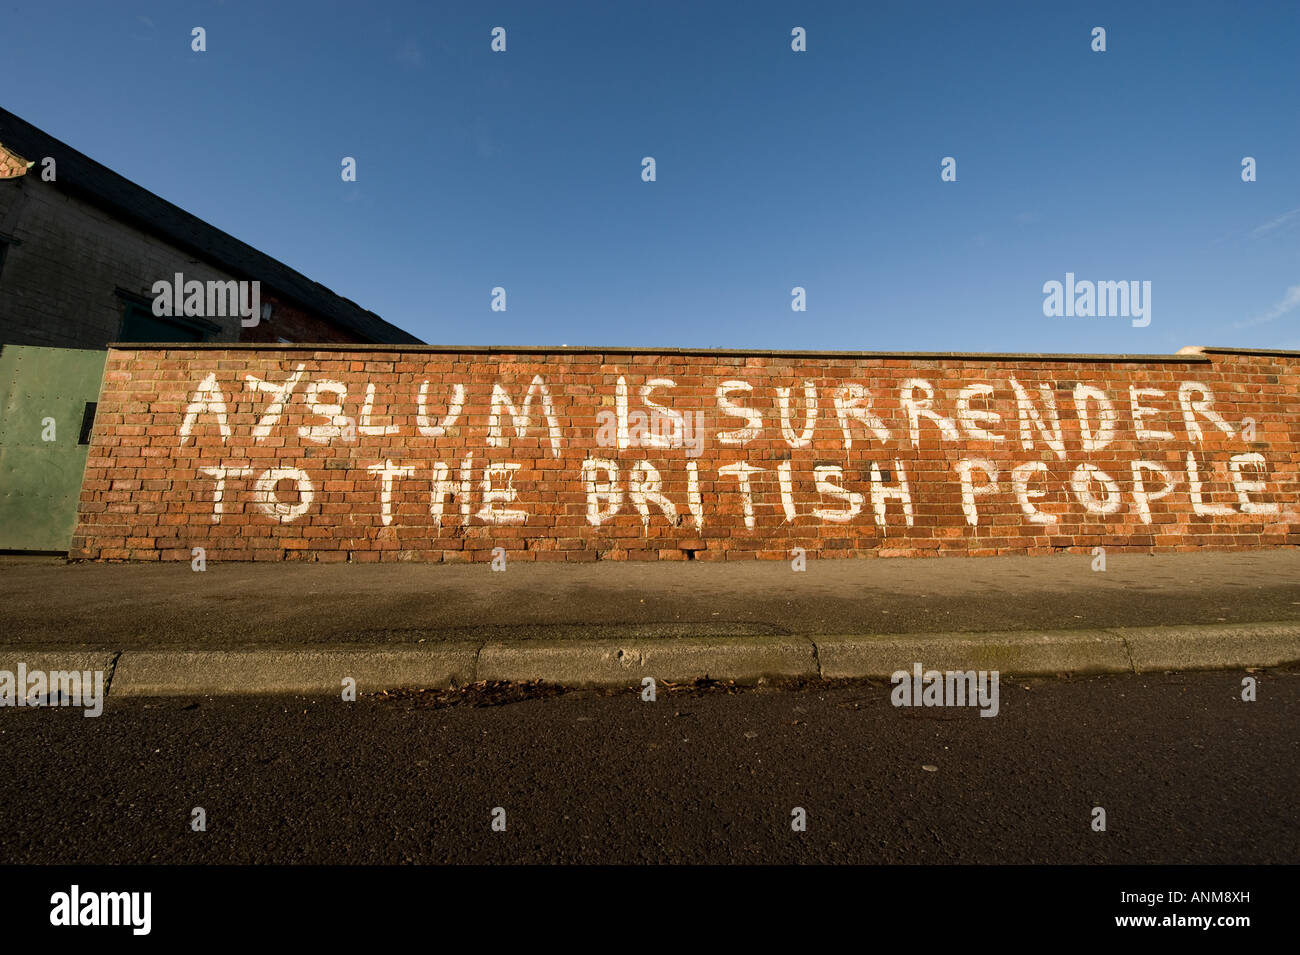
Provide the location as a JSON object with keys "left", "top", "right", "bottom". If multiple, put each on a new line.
{"left": 0, "top": 108, "right": 423, "bottom": 344}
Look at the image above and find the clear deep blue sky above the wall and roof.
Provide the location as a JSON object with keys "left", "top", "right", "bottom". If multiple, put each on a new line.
{"left": 0, "top": 0, "right": 1300, "bottom": 352}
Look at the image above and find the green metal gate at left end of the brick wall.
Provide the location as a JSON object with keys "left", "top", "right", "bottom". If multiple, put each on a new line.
{"left": 0, "top": 344, "right": 108, "bottom": 554}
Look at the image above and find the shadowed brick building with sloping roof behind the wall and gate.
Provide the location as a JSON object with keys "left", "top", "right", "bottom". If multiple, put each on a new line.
{"left": 0, "top": 109, "right": 420, "bottom": 350}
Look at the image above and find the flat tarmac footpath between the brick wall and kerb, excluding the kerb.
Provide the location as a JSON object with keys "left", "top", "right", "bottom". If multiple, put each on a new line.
{"left": 0, "top": 550, "right": 1300, "bottom": 650}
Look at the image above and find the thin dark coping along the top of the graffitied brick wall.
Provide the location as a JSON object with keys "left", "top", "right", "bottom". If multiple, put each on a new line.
{"left": 109, "top": 342, "right": 1227, "bottom": 364}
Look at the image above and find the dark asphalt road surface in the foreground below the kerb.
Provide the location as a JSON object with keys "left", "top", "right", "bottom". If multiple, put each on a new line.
{"left": 0, "top": 670, "right": 1300, "bottom": 864}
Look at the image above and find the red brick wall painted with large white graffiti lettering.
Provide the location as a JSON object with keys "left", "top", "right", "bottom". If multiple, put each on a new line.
{"left": 72, "top": 347, "right": 1300, "bottom": 561}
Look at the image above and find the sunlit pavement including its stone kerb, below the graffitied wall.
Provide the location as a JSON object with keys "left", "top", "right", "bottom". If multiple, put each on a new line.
{"left": 0, "top": 550, "right": 1300, "bottom": 696}
